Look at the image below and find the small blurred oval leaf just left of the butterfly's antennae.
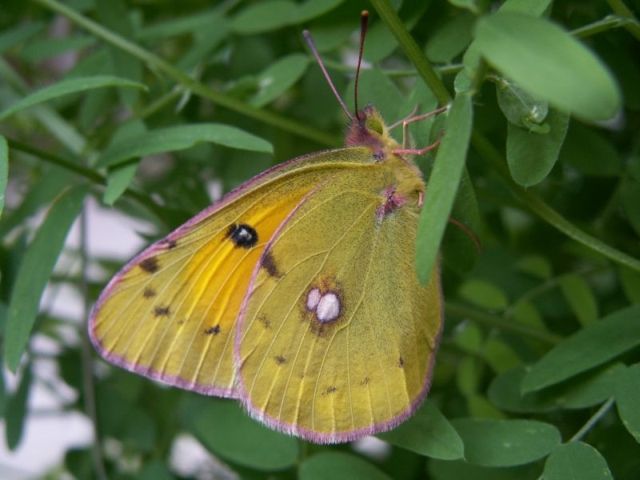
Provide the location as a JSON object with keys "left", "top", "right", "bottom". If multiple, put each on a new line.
{"left": 249, "top": 53, "right": 309, "bottom": 107}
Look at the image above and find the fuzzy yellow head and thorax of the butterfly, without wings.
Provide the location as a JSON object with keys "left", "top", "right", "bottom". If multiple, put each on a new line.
{"left": 346, "top": 105, "right": 425, "bottom": 215}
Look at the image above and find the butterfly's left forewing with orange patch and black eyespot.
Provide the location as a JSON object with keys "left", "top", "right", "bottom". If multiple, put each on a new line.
{"left": 89, "top": 148, "right": 372, "bottom": 397}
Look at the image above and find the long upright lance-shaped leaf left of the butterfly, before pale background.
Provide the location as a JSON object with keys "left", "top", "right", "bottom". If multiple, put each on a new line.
{"left": 4, "top": 187, "right": 87, "bottom": 372}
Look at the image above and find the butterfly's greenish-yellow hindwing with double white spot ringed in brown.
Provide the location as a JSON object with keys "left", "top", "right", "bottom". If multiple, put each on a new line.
{"left": 235, "top": 160, "right": 442, "bottom": 443}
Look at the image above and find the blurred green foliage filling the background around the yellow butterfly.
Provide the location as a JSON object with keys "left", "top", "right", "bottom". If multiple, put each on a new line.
{"left": 0, "top": 0, "right": 640, "bottom": 480}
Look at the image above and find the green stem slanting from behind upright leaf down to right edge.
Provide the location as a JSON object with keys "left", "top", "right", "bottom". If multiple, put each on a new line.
{"left": 471, "top": 132, "right": 640, "bottom": 272}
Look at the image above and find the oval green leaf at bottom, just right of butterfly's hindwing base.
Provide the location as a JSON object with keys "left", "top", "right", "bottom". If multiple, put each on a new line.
{"left": 452, "top": 418, "right": 560, "bottom": 467}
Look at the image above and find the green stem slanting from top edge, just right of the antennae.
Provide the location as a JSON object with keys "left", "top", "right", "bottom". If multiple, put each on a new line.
{"left": 371, "top": 0, "right": 451, "bottom": 105}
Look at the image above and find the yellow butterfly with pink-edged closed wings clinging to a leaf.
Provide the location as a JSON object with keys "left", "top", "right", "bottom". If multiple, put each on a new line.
{"left": 89, "top": 11, "right": 443, "bottom": 443}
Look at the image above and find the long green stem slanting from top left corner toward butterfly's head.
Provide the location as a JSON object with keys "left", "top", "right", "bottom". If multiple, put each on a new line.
{"left": 35, "top": 0, "right": 340, "bottom": 145}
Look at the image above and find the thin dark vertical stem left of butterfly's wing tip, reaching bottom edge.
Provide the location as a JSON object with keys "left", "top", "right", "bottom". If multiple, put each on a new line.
{"left": 80, "top": 204, "right": 107, "bottom": 480}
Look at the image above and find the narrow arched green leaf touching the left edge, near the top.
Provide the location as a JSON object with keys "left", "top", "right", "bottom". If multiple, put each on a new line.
{"left": 0, "top": 75, "right": 147, "bottom": 120}
